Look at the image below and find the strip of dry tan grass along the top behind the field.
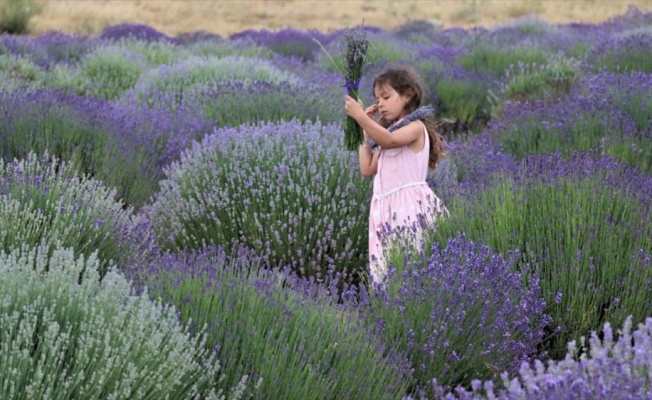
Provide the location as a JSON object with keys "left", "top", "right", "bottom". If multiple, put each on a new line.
{"left": 26, "top": 0, "right": 652, "bottom": 36}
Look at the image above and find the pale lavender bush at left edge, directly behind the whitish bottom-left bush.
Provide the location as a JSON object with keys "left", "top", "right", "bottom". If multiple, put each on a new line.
{"left": 0, "top": 153, "right": 155, "bottom": 275}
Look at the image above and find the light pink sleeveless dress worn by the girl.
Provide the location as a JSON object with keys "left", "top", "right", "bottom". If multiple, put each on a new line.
{"left": 369, "top": 121, "right": 448, "bottom": 282}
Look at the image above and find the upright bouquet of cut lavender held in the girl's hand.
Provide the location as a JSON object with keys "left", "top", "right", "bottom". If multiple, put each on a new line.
{"left": 313, "top": 20, "right": 369, "bottom": 150}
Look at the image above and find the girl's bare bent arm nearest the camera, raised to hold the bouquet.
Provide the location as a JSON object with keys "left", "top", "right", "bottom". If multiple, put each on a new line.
{"left": 344, "top": 95, "right": 423, "bottom": 149}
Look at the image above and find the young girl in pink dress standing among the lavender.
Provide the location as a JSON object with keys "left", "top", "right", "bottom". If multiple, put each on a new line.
{"left": 344, "top": 67, "right": 448, "bottom": 283}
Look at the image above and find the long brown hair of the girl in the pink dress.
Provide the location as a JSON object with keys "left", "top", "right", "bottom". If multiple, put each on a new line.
{"left": 372, "top": 66, "right": 446, "bottom": 170}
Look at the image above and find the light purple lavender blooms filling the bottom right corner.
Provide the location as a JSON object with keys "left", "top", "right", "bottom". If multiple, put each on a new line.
{"left": 433, "top": 317, "right": 652, "bottom": 400}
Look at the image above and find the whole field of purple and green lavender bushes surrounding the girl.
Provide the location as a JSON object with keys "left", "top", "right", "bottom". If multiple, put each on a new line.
{"left": 0, "top": 7, "right": 652, "bottom": 400}
